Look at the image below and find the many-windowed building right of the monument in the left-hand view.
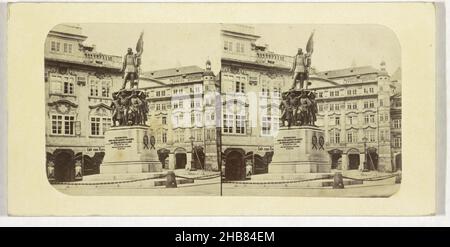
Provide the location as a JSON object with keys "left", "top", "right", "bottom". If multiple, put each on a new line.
{"left": 140, "top": 61, "right": 220, "bottom": 171}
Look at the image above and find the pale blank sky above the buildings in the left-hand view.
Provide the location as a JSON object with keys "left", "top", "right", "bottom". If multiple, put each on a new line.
{"left": 80, "top": 23, "right": 221, "bottom": 73}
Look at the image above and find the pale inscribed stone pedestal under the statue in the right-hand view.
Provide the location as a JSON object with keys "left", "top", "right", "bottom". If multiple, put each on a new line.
{"left": 269, "top": 126, "right": 331, "bottom": 174}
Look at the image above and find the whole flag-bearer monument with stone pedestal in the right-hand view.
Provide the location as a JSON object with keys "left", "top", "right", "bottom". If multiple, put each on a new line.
{"left": 269, "top": 33, "right": 331, "bottom": 174}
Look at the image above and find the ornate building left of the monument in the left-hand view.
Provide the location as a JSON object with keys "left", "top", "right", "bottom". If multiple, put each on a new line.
{"left": 44, "top": 25, "right": 122, "bottom": 181}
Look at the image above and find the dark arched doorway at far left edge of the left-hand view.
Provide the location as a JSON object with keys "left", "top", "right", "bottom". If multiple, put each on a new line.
{"left": 54, "top": 149, "right": 75, "bottom": 182}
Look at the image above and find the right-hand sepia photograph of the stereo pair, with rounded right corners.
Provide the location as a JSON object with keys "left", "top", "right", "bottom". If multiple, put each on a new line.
{"left": 220, "top": 24, "right": 402, "bottom": 197}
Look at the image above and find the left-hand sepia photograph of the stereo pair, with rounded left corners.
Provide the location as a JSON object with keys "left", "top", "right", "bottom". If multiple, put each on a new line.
{"left": 45, "top": 24, "right": 220, "bottom": 195}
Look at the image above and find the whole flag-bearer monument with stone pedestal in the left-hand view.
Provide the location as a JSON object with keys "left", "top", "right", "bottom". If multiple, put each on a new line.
{"left": 100, "top": 33, "right": 162, "bottom": 174}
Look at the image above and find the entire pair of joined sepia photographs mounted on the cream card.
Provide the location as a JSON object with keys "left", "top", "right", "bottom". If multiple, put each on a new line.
{"left": 44, "top": 23, "right": 402, "bottom": 197}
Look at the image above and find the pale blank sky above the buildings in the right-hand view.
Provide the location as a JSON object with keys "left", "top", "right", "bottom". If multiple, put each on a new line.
{"left": 253, "top": 24, "right": 401, "bottom": 74}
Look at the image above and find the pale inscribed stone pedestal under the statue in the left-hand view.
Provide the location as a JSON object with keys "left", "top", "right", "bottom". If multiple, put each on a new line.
{"left": 100, "top": 126, "right": 162, "bottom": 174}
